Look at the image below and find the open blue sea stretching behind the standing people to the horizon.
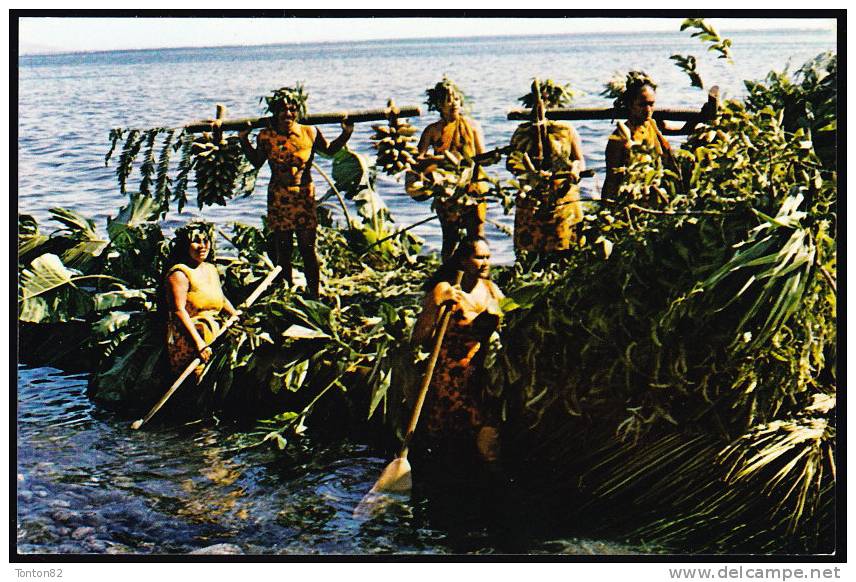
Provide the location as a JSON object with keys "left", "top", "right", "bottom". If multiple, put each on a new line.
{"left": 18, "top": 30, "right": 835, "bottom": 262}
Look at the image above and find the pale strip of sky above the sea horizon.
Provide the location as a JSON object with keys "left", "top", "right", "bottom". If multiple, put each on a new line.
{"left": 19, "top": 17, "right": 835, "bottom": 54}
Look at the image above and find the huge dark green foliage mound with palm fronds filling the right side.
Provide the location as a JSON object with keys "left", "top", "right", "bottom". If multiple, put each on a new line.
{"left": 492, "top": 52, "right": 837, "bottom": 552}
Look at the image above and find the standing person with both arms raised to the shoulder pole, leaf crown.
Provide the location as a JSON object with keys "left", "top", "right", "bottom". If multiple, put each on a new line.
{"left": 240, "top": 84, "right": 354, "bottom": 299}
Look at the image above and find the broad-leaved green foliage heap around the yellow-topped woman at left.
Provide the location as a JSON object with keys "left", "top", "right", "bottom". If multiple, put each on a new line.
{"left": 18, "top": 140, "right": 436, "bottom": 446}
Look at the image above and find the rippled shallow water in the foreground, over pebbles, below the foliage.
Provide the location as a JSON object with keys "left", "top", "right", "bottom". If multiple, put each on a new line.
{"left": 17, "top": 367, "right": 632, "bottom": 554}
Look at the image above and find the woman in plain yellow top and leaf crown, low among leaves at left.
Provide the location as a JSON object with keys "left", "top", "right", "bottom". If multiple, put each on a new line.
{"left": 164, "top": 222, "right": 237, "bottom": 378}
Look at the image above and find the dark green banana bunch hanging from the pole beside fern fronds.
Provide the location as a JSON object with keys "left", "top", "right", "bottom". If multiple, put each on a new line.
{"left": 192, "top": 136, "right": 256, "bottom": 208}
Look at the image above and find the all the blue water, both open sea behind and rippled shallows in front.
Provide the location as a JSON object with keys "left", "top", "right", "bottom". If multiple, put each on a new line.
{"left": 17, "top": 27, "right": 836, "bottom": 554}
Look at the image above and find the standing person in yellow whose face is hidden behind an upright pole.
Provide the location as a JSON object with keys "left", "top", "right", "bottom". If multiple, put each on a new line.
{"left": 506, "top": 79, "right": 585, "bottom": 255}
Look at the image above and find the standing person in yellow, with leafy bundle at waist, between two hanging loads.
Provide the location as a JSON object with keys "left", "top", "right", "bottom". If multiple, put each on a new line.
{"left": 405, "top": 77, "right": 487, "bottom": 259}
